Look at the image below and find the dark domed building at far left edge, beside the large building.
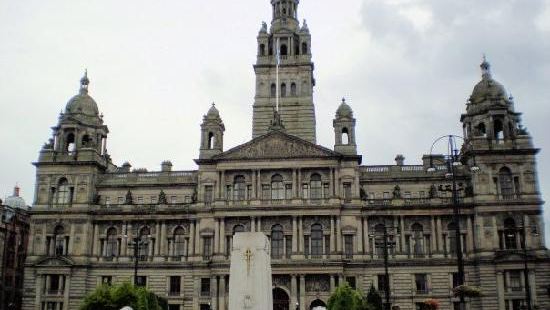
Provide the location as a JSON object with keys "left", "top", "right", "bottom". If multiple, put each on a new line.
{"left": 0, "top": 186, "right": 29, "bottom": 310}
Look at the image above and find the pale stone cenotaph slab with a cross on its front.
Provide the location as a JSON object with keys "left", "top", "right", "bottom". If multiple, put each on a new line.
{"left": 229, "top": 232, "right": 273, "bottom": 310}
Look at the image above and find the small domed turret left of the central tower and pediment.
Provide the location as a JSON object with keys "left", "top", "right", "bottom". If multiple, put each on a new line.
{"left": 199, "top": 103, "right": 225, "bottom": 159}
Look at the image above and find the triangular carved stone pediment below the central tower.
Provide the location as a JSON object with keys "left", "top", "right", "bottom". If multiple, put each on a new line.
{"left": 213, "top": 131, "right": 341, "bottom": 160}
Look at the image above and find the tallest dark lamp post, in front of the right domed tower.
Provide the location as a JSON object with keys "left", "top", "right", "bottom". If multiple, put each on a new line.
{"left": 428, "top": 135, "right": 479, "bottom": 310}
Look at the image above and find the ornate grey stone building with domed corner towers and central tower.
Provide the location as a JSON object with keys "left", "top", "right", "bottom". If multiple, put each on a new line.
{"left": 23, "top": 0, "right": 550, "bottom": 310}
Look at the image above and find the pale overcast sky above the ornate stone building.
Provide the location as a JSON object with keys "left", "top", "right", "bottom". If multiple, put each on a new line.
{"left": 0, "top": 0, "right": 550, "bottom": 242}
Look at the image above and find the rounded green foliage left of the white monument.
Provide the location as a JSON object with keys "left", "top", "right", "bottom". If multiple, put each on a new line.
{"left": 80, "top": 283, "right": 168, "bottom": 310}
